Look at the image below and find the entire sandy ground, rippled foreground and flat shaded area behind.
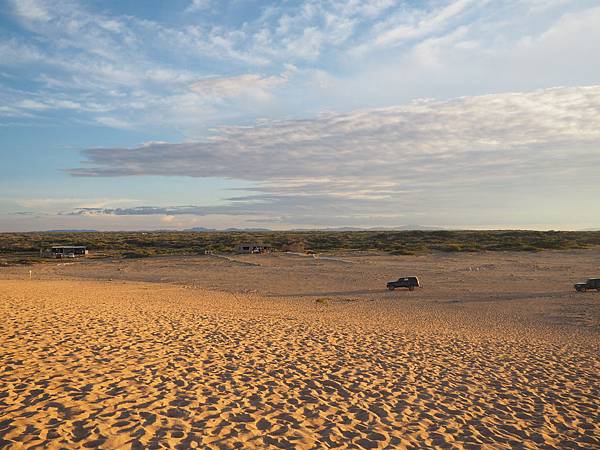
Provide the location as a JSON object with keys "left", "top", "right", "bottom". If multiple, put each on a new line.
{"left": 0, "top": 249, "right": 600, "bottom": 449}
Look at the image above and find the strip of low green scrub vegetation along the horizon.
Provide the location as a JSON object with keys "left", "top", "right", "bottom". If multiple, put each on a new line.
{"left": 0, "top": 230, "right": 600, "bottom": 263}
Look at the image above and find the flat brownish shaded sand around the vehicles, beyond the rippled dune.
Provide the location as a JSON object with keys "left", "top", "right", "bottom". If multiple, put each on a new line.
{"left": 0, "top": 247, "right": 600, "bottom": 333}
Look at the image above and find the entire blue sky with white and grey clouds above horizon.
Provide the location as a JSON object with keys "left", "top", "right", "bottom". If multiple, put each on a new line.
{"left": 0, "top": 0, "right": 600, "bottom": 231}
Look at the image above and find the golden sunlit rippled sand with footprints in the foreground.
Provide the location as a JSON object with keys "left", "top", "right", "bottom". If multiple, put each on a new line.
{"left": 0, "top": 280, "right": 600, "bottom": 449}
